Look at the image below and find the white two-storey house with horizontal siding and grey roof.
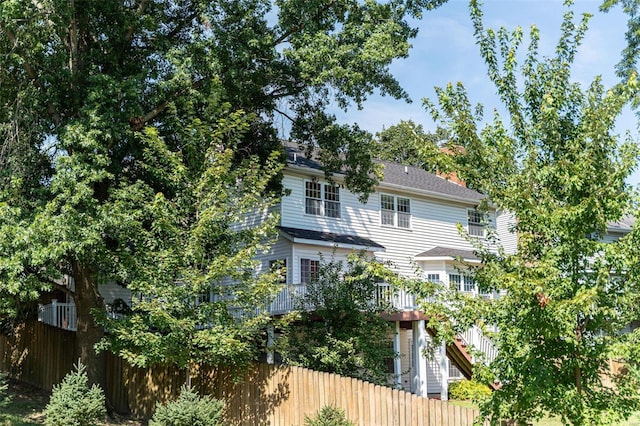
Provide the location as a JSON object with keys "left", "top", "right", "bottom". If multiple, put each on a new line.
{"left": 254, "top": 144, "right": 516, "bottom": 398}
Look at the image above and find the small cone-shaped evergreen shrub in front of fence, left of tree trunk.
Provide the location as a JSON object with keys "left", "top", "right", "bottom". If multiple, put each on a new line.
{"left": 44, "top": 363, "right": 106, "bottom": 426}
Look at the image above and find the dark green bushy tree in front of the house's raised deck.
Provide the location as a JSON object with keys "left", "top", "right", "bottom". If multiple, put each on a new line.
{"left": 280, "top": 253, "right": 397, "bottom": 384}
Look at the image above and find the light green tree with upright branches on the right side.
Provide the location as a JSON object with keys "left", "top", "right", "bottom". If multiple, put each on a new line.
{"left": 427, "top": 0, "right": 640, "bottom": 425}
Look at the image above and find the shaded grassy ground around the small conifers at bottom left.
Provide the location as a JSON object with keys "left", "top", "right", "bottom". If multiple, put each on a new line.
{"left": 0, "top": 380, "right": 143, "bottom": 426}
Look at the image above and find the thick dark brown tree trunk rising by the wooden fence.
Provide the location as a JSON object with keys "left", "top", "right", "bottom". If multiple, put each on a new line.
{"left": 73, "top": 262, "right": 106, "bottom": 390}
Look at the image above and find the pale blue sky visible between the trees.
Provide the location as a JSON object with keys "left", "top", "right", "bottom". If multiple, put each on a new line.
{"left": 336, "top": 0, "right": 640, "bottom": 185}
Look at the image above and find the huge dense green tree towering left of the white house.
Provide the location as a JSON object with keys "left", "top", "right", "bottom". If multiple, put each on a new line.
{"left": 0, "top": 0, "right": 443, "bottom": 392}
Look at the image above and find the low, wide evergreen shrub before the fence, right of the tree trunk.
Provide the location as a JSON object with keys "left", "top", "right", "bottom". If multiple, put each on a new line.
{"left": 149, "top": 386, "right": 224, "bottom": 426}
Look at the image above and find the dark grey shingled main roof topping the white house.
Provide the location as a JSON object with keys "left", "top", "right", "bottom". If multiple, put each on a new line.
{"left": 284, "top": 142, "right": 485, "bottom": 204}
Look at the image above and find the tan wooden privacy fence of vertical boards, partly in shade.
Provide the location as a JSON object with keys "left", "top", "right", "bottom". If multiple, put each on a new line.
{"left": 0, "top": 322, "right": 479, "bottom": 426}
